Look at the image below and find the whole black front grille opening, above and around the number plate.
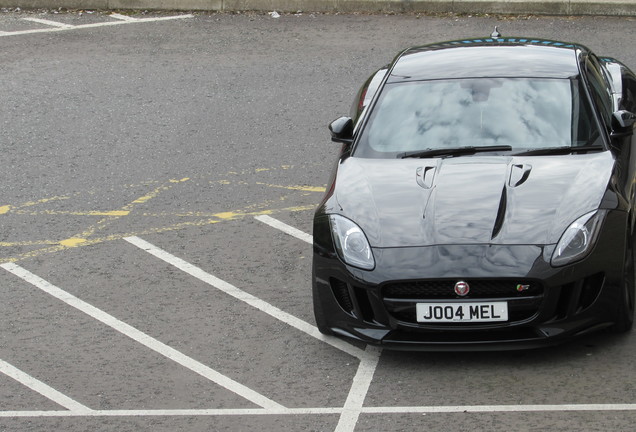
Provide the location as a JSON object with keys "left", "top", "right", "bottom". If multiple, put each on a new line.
{"left": 381, "top": 279, "right": 543, "bottom": 326}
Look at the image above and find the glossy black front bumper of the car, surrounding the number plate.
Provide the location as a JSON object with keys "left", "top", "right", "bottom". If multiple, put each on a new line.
{"left": 313, "top": 211, "right": 627, "bottom": 351}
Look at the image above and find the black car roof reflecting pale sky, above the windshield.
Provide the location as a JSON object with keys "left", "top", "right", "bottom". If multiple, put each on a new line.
{"left": 388, "top": 38, "right": 589, "bottom": 83}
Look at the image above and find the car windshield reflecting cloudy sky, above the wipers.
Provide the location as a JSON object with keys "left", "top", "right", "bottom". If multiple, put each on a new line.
{"left": 354, "top": 78, "right": 602, "bottom": 158}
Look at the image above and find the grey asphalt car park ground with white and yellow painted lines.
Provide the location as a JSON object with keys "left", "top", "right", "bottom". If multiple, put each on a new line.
{"left": 0, "top": 9, "right": 636, "bottom": 432}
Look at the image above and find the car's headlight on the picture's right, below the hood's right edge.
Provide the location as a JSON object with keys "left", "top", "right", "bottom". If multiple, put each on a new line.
{"left": 552, "top": 210, "right": 605, "bottom": 267}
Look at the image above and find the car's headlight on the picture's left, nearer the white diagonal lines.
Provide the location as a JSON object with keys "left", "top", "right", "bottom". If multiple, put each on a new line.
{"left": 329, "top": 215, "right": 375, "bottom": 270}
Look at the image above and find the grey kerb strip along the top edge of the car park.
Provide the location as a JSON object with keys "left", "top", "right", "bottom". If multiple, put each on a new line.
{"left": 0, "top": 0, "right": 636, "bottom": 16}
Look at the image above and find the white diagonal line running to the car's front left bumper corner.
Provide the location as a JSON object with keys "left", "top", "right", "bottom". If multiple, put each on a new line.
{"left": 124, "top": 237, "right": 368, "bottom": 359}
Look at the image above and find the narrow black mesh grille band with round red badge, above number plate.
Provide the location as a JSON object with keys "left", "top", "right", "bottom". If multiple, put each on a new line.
{"left": 382, "top": 279, "right": 543, "bottom": 300}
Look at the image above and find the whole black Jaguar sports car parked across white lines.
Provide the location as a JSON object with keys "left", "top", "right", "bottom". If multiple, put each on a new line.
{"left": 312, "top": 34, "right": 636, "bottom": 350}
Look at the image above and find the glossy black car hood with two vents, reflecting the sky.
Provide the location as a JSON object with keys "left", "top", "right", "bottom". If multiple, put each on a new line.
{"left": 326, "top": 151, "right": 614, "bottom": 247}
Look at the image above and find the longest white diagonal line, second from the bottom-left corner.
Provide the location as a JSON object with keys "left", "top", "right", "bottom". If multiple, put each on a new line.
{"left": 0, "top": 263, "right": 284, "bottom": 409}
